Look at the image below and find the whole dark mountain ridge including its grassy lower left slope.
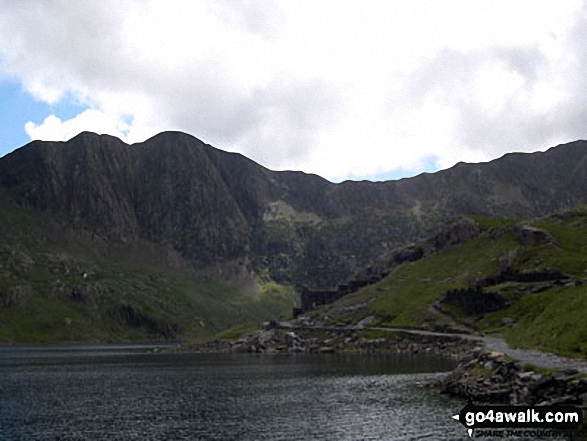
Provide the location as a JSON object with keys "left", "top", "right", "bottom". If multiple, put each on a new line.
{"left": 0, "top": 132, "right": 587, "bottom": 341}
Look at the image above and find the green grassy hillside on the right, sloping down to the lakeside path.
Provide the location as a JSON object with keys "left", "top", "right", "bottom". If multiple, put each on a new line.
{"left": 312, "top": 207, "right": 587, "bottom": 357}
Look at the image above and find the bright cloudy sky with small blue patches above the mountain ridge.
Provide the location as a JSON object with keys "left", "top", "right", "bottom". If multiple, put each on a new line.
{"left": 0, "top": 0, "right": 587, "bottom": 182}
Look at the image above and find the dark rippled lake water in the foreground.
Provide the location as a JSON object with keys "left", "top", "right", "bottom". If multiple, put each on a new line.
{"left": 0, "top": 345, "right": 468, "bottom": 440}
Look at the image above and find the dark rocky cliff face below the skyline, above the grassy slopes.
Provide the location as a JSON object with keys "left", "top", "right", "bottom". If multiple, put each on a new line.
{"left": 0, "top": 132, "right": 587, "bottom": 288}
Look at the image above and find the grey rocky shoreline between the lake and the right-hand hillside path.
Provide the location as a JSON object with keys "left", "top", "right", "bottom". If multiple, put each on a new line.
{"left": 175, "top": 322, "right": 587, "bottom": 405}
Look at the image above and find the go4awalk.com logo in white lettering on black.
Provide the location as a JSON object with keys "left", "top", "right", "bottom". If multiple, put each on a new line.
{"left": 453, "top": 402, "right": 583, "bottom": 438}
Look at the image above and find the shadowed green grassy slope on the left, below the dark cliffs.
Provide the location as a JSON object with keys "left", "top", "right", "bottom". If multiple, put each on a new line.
{"left": 0, "top": 194, "right": 297, "bottom": 343}
